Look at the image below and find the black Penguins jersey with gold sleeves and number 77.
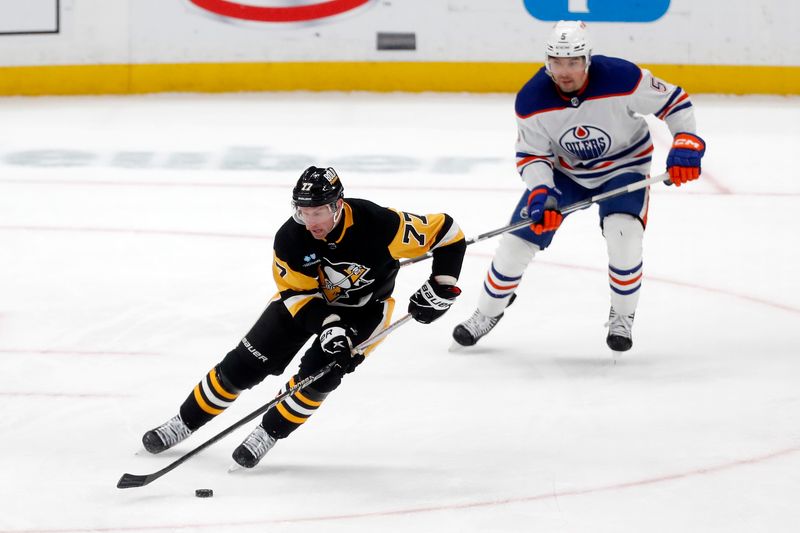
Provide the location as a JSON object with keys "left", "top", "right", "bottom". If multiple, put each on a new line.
{"left": 273, "top": 198, "right": 466, "bottom": 332}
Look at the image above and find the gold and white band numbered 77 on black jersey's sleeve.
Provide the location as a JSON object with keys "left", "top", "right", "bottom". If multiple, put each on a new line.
{"left": 389, "top": 209, "right": 464, "bottom": 259}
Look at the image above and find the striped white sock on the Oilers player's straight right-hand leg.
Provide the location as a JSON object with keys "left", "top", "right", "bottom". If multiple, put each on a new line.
{"left": 603, "top": 213, "right": 644, "bottom": 315}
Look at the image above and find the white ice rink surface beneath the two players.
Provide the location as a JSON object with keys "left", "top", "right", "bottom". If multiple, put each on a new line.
{"left": 0, "top": 93, "right": 800, "bottom": 533}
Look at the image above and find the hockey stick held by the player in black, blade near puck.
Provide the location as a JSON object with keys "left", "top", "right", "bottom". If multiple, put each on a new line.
{"left": 117, "top": 314, "right": 411, "bottom": 489}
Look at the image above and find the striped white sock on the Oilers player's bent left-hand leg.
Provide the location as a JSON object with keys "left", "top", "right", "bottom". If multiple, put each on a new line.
{"left": 478, "top": 233, "right": 539, "bottom": 316}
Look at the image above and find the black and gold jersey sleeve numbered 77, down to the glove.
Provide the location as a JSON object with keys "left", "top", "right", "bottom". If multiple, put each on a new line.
{"left": 389, "top": 209, "right": 467, "bottom": 282}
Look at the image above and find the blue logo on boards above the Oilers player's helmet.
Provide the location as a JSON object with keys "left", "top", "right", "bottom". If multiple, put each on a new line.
{"left": 524, "top": 0, "right": 670, "bottom": 22}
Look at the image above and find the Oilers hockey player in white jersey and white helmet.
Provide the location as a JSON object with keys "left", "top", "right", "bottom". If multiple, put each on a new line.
{"left": 453, "top": 21, "right": 705, "bottom": 352}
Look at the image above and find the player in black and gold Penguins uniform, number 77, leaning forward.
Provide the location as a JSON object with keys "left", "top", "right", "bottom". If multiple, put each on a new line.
{"left": 142, "top": 167, "right": 466, "bottom": 468}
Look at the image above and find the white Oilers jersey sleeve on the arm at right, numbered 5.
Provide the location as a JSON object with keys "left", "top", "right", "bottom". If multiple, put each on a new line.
{"left": 631, "top": 69, "right": 696, "bottom": 136}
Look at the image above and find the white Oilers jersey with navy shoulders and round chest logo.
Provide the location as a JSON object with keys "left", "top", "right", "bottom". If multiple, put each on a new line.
{"left": 515, "top": 56, "right": 695, "bottom": 189}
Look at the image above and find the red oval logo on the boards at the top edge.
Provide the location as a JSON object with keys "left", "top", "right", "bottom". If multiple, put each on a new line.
{"left": 189, "top": 0, "right": 370, "bottom": 22}
